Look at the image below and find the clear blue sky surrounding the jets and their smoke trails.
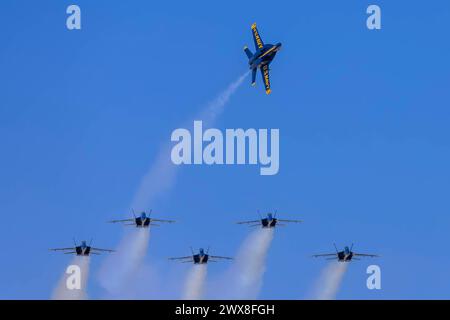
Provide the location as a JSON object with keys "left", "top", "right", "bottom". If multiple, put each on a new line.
{"left": 0, "top": 0, "right": 450, "bottom": 299}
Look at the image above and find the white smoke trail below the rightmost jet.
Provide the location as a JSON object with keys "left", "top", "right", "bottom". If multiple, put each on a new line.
{"left": 314, "top": 261, "right": 348, "bottom": 300}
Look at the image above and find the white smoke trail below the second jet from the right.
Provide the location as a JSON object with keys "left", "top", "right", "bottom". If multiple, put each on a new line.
{"left": 217, "top": 228, "right": 274, "bottom": 299}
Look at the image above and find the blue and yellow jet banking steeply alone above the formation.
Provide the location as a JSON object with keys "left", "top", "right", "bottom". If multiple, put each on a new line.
{"left": 244, "top": 23, "right": 281, "bottom": 94}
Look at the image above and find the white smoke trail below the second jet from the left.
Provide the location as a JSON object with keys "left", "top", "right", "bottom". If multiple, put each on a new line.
{"left": 99, "top": 228, "right": 150, "bottom": 298}
